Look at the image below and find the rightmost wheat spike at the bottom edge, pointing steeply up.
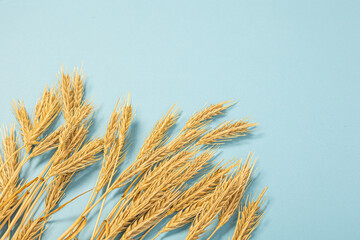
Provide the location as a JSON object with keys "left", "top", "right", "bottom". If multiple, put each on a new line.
{"left": 232, "top": 187, "right": 267, "bottom": 240}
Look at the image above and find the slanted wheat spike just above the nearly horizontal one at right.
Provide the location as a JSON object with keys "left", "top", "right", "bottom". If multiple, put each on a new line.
{"left": 183, "top": 101, "right": 233, "bottom": 130}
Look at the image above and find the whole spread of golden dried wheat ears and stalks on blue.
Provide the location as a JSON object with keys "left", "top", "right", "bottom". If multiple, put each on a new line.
{"left": 0, "top": 68, "right": 266, "bottom": 240}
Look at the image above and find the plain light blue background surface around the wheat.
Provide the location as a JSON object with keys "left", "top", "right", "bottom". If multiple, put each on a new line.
{"left": 0, "top": 0, "right": 360, "bottom": 240}
